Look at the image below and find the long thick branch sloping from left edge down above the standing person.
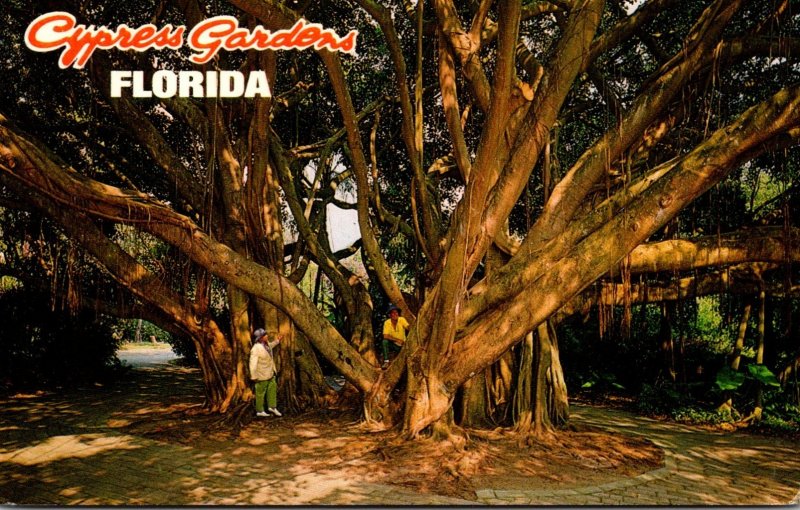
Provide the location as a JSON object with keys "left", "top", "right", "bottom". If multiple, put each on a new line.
{"left": 0, "top": 118, "right": 377, "bottom": 391}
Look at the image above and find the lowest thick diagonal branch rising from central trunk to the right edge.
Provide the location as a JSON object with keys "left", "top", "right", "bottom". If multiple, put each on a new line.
{"left": 445, "top": 82, "right": 800, "bottom": 386}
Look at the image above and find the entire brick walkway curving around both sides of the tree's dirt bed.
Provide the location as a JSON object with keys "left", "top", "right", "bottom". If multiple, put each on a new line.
{"left": 0, "top": 363, "right": 800, "bottom": 506}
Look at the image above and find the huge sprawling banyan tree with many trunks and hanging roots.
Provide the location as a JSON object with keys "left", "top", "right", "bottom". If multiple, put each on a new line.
{"left": 0, "top": 0, "right": 800, "bottom": 438}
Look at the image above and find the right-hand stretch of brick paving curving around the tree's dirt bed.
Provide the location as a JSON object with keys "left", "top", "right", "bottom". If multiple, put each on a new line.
{"left": 478, "top": 406, "right": 800, "bottom": 506}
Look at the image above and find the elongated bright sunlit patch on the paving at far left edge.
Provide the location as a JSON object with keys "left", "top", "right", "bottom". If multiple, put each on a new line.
{"left": 0, "top": 434, "right": 141, "bottom": 466}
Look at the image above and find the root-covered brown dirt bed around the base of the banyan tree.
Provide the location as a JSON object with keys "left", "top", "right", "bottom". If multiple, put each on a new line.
{"left": 121, "top": 405, "right": 663, "bottom": 500}
